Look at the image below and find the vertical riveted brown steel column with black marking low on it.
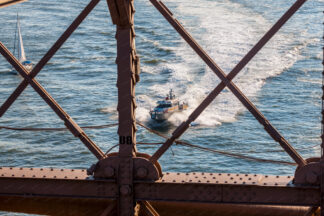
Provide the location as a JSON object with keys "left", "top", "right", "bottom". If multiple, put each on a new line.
{"left": 114, "top": 0, "right": 136, "bottom": 216}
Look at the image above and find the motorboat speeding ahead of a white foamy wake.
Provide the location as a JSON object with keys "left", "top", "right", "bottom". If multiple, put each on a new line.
{"left": 150, "top": 89, "right": 188, "bottom": 122}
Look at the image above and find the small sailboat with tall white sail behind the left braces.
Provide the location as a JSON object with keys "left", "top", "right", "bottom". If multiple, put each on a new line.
{"left": 13, "top": 13, "right": 33, "bottom": 71}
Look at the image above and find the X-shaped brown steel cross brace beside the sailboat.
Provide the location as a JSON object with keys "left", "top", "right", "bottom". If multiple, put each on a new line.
{"left": 0, "top": 0, "right": 105, "bottom": 159}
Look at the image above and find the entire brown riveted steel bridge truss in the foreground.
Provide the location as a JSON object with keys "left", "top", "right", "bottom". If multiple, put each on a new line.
{"left": 0, "top": 0, "right": 324, "bottom": 216}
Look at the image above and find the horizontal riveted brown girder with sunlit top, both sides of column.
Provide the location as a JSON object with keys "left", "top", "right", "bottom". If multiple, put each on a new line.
{"left": 0, "top": 167, "right": 320, "bottom": 208}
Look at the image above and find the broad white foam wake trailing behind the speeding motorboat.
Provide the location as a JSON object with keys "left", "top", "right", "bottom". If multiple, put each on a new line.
{"left": 136, "top": 0, "right": 312, "bottom": 126}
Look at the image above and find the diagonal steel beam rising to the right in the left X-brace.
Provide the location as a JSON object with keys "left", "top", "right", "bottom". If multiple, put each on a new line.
{"left": 0, "top": 0, "right": 100, "bottom": 117}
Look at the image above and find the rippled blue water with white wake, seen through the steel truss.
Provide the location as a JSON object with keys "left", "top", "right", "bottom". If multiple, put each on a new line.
{"left": 0, "top": 0, "right": 324, "bottom": 187}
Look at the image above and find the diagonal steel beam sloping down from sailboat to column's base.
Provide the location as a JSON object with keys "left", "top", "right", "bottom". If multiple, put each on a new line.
{"left": 0, "top": 42, "right": 105, "bottom": 160}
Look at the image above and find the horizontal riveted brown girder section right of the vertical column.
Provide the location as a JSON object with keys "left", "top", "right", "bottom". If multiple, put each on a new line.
{"left": 135, "top": 173, "right": 320, "bottom": 205}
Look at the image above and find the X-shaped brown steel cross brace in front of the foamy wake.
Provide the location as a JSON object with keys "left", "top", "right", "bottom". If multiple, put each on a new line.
{"left": 150, "top": 0, "right": 306, "bottom": 166}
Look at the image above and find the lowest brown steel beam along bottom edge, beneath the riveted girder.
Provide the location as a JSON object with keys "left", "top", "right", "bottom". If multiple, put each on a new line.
{"left": 0, "top": 196, "right": 315, "bottom": 216}
